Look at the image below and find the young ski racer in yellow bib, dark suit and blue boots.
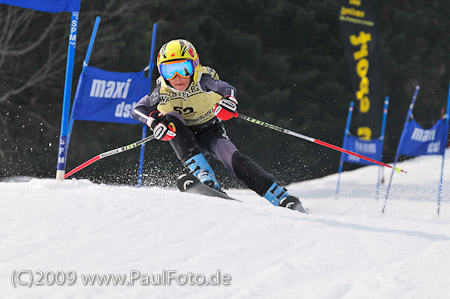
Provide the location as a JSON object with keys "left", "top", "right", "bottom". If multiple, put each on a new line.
{"left": 132, "top": 39, "right": 305, "bottom": 212}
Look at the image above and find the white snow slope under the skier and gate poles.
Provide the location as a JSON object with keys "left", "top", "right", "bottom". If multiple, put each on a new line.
{"left": 0, "top": 153, "right": 450, "bottom": 299}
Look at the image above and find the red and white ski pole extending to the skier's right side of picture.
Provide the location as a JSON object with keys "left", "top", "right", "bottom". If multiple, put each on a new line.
{"left": 237, "top": 114, "right": 406, "bottom": 173}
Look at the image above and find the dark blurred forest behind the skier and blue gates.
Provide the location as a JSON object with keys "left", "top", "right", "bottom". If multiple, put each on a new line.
{"left": 0, "top": 0, "right": 450, "bottom": 186}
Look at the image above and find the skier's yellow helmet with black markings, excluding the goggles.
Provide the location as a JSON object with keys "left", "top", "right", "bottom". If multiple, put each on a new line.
{"left": 156, "top": 39, "right": 200, "bottom": 81}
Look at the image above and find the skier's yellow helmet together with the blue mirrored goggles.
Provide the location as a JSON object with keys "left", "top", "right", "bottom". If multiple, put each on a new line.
{"left": 156, "top": 39, "right": 200, "bottom": 81}
